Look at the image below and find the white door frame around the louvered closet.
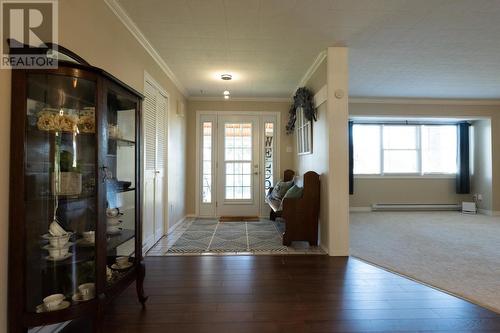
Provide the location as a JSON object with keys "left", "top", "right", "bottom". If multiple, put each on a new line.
{"left": 140, "top": 71, "right": 170, "bottom": 248}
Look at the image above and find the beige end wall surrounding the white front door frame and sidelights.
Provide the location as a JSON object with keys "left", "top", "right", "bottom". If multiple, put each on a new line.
{"left": 186, "top": 100, "right": 294, "bottom": 214}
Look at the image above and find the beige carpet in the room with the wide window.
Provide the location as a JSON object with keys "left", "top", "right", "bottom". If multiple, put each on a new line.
{"left": 350, "top": 212, "right": 500, "bottom": 312}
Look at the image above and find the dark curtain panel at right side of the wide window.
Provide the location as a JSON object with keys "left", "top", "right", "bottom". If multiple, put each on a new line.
{"left": 457, "top": 122, "right": 470, "bottom": 194}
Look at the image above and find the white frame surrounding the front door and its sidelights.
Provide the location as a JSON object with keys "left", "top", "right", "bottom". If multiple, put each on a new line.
{"left": 195, "top": 110, "right": 281, "bottom": 217}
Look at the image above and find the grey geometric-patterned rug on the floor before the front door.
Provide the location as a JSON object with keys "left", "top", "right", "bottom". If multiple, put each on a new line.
{"left": 167, "top": 219, "right": 287, "bottom": 253}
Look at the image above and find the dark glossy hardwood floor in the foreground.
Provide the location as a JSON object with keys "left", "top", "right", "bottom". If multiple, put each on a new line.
{"left": 102, "top": 256, "right": 500, "bottom": 333}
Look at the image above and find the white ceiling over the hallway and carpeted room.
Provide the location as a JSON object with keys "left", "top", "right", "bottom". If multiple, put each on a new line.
{"left": 119, "top": 0, "right": 500, "bottom": 99}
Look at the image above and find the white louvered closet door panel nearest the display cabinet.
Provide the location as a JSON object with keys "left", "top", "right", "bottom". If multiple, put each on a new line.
{"left": 142, "top": 82, "right": 157, "bottom": 252}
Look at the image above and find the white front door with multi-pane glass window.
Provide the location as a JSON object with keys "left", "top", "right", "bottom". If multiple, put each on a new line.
{"left": 217, "top": 115, "right": 260, "bottom": 216}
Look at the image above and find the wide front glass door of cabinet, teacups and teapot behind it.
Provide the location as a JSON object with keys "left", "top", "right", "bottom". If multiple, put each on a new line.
{"left": 25, "top": 74, "right": 97, "bottom": 313}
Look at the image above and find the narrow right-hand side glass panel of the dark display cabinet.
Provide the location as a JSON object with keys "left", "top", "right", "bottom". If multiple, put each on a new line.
{"left": 105, "top": 89, "right": 138, "bottom": 285}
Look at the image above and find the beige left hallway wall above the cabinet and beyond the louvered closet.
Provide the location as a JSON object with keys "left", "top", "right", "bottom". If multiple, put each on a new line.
{"left": 59, "top": 0, "right": 186, "bottom": 225}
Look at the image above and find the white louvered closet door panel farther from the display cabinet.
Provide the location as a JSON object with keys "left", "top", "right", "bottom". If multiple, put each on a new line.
{"left": 154, "top": 92, "right": 168, "bottom": 243}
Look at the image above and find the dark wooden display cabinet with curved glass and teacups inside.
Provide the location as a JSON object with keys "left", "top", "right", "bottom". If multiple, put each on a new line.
{"left": 8, "top": 47, "right": 146, "bottom": 332}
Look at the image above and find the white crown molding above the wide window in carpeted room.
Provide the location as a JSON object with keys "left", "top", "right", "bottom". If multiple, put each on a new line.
{"left": 349, "top": 97, "right": 500, "bottom": 106}
